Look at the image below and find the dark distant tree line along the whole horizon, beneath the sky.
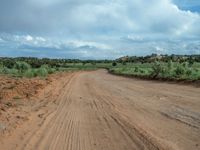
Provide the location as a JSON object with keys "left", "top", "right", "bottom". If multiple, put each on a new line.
{"left": 0, "top": 54, "right": 200, "bottom": 68}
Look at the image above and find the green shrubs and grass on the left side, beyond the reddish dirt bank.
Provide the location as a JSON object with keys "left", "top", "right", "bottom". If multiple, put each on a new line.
{"left": 0, "top": 57, "right": 112, "bottom": 78}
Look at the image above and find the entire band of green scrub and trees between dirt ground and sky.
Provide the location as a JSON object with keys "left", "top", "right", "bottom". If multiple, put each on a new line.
{"left": 0, "top": 54, "right": 200, "bottom": 81}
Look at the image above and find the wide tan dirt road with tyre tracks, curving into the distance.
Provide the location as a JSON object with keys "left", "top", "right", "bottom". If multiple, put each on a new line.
{"left": 0, "top": 70, "right": 200, "bottom": 150}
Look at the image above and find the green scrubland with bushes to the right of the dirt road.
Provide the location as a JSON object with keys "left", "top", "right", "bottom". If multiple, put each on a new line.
{"left": 109, "top": 55, "right": 200, "bottom": 80}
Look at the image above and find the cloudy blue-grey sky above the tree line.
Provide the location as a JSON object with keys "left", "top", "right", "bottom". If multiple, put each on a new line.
{"left": 0, "top": 0, "right": 200, "bottom": 59}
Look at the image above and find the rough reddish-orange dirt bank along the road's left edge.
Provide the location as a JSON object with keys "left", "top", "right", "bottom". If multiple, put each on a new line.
{"left": 0, "top": 73, "right": 76, "bottom": 136}
